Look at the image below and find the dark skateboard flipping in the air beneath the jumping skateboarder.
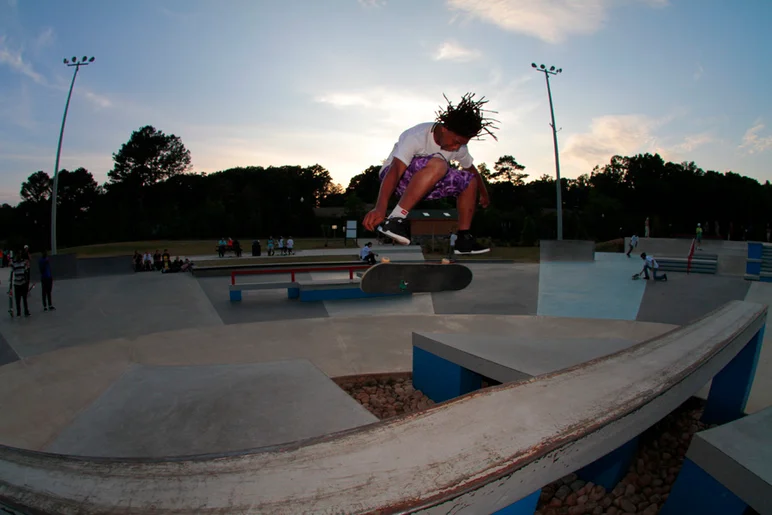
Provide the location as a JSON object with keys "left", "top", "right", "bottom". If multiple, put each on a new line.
{"left": 359, "top": 263, "right": 472, "bottom": 293}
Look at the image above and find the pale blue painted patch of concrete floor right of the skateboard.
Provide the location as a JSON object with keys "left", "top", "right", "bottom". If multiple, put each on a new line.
{"left": 537, "top": 252, "right": 646, "bottom": 320}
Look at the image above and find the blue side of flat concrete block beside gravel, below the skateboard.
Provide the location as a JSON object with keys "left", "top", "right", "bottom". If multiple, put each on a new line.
{"left": 413, "top": 346, "right": 482, "bottom": 402}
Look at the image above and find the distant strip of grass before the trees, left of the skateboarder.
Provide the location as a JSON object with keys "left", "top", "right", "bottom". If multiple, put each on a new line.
{"left": 59, "top": 238, "right": 356, "bottom": 257}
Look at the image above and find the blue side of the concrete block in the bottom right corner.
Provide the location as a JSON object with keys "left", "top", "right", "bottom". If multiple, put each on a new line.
{"left": 659, "top": 458, "right": 747, "bottom": 515}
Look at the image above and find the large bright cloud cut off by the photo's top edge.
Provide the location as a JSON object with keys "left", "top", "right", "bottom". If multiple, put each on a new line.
{"left": 446, "top": 0, "right": 668, "bottom": 43}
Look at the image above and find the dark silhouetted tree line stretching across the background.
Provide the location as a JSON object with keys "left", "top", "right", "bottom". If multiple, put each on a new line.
{"left": 0, "top": 125, "right": 772, "bottom": 254}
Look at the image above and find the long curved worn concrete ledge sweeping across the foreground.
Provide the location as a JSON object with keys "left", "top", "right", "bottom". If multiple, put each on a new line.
{"left": 0, "top": 301, "right": 767, "bottom": 514}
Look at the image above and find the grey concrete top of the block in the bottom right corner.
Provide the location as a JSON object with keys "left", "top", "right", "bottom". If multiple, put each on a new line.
{"left": 686, "top": 407, "right": 772, "bottom": 513}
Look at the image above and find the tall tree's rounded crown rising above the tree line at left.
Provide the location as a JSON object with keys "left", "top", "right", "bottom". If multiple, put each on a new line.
{"left": 107, "top": 125, "right": 191, "bottom": 187}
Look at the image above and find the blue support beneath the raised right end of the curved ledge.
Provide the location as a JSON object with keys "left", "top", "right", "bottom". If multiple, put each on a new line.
{"left": 702, "top": 326, "right": 766, "bottom": 424}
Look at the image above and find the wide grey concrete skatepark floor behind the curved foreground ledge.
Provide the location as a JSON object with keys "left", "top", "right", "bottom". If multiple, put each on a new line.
{"left": 0, "top": 240, "right": 772, "bottom": 462}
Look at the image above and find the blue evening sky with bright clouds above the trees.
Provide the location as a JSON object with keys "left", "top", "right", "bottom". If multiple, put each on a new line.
{"left": 0, "top": 0, "right": 772, "bottom": 205}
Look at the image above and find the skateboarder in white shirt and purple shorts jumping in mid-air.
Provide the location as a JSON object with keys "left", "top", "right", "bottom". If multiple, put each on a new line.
{"left": 362, "top": 93, "right": 497, "bottom": 254}
